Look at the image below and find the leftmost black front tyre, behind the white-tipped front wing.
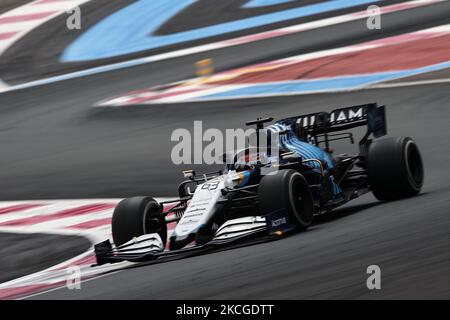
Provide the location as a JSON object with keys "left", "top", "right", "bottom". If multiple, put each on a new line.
{"left": 111, "top": 197, "right": 167, "bottom": 246}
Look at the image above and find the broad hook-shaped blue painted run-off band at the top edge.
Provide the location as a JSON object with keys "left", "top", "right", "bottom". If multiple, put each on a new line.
{"left": 61, "top": 0, "right": 378, "bottom": 62}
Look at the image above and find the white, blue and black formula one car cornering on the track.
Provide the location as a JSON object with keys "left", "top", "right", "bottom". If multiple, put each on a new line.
{"left": 95, "top": 103, "right": 424, "bottom": 264}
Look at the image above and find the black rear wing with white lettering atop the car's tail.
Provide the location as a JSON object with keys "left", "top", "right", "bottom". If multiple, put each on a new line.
{"left": 278, "top": 103, "right": 387, "bottom": 138}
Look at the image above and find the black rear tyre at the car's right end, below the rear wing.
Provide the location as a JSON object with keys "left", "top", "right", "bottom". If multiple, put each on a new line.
{"left": 367, "top": 137, "right": 424, "bottom": 200}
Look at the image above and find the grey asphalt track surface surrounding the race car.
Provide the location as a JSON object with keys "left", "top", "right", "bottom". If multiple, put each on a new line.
{"left": 0, "top": 3, "right": 450, "bottom": 299}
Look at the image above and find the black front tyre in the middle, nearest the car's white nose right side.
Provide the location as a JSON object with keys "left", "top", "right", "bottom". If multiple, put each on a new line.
{"left": 258, "top": 169, "right": 314, "bottom": 230}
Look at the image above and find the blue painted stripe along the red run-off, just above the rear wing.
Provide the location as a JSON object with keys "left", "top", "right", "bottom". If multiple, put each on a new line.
{"left": 196, "top": 61, "right": 450, "bottom": 100}
